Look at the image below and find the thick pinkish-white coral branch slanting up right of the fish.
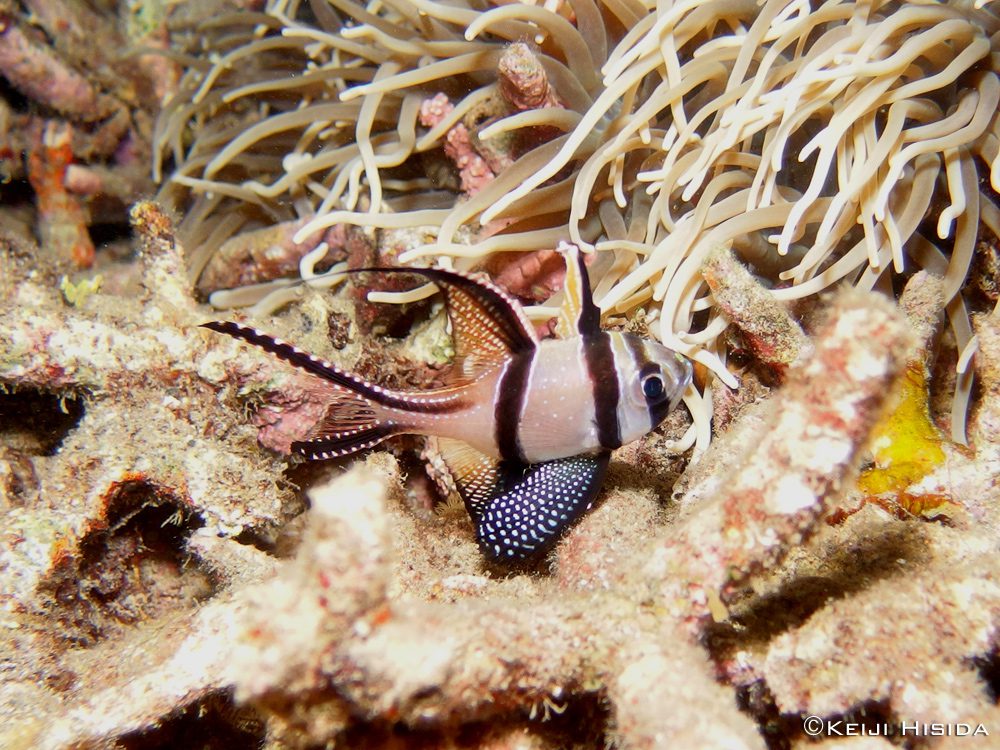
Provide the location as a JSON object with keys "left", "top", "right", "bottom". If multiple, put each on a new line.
{"left": 644, "top": 293, "right": 910, "bottom": 630}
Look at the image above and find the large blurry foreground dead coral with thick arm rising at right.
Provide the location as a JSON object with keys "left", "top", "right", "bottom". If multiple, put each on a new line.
{"left": 0, "top": 284, "right": 936, "bottom": 749}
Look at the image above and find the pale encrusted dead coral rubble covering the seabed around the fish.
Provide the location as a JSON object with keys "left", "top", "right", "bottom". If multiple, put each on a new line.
{"left": 9, "top": 220, "right": 1000, "bottom": 748}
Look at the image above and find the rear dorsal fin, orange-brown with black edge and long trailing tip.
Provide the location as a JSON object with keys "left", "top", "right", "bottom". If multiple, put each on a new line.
{"left": 359, "top": 268, "right": 538, "bottom": 380}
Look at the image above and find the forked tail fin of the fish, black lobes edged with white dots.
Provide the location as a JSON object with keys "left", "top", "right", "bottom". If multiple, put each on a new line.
{"left": 202, "top": 321, "right": 407, "bottom": 459}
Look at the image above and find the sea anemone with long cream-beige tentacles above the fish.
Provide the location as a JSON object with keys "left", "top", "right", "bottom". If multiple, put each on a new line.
{"left": 155, "top": 0, "right": 1000, "bottom": 447}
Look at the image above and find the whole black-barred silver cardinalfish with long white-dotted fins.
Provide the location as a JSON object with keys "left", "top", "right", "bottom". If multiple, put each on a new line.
{"left": 203, "top": 243, "right": 692, "bottom": 565}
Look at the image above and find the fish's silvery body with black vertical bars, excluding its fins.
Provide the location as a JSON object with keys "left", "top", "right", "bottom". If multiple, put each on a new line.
{"left": 394, "top": 331, "right": 691, "bottom": 464}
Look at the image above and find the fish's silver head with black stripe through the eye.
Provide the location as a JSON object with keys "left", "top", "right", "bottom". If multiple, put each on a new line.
{"left": 618, "top": 334, "right": 692, "bottom": 444}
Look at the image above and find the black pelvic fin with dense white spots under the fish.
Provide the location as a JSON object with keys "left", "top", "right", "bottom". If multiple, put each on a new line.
{"left": 484, "top": 451, "right": 611, "bottom": 565}
